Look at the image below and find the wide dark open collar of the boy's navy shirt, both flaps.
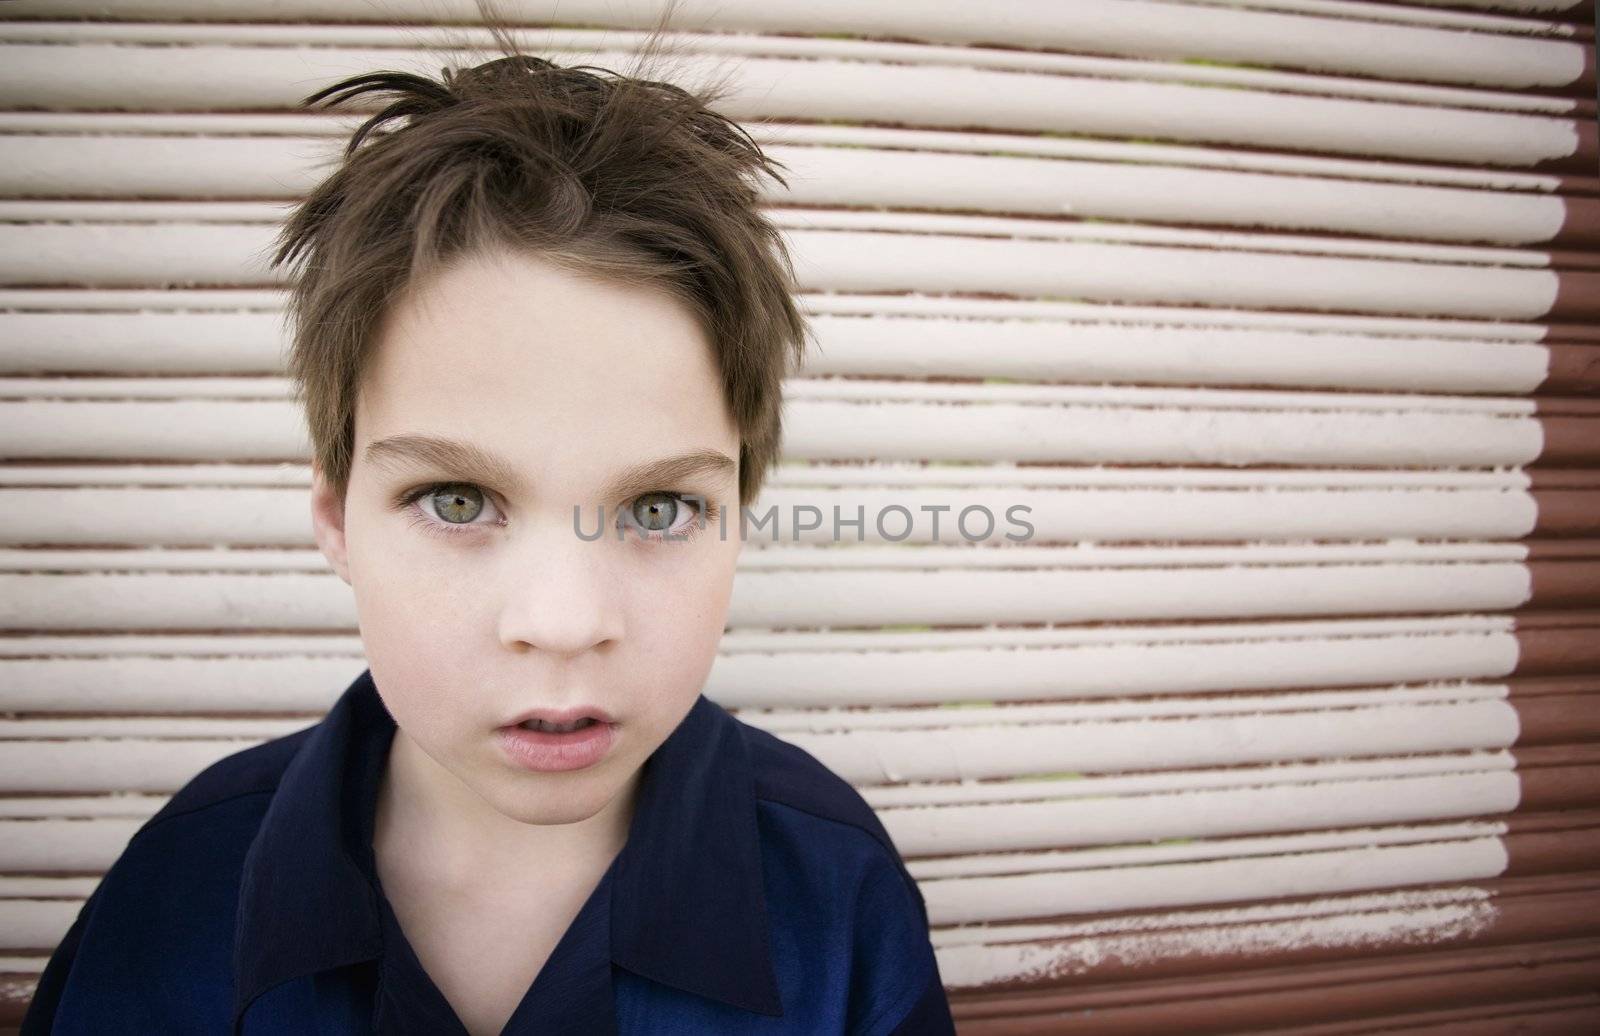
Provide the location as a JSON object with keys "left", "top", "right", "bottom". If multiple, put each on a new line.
{"left": 234, "top": 670, "right": 782, "bottom": 1033}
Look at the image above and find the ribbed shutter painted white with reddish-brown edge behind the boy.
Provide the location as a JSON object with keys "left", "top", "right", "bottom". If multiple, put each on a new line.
{"left": 0, "top": 0, "right": 1600, "bottom": 1036}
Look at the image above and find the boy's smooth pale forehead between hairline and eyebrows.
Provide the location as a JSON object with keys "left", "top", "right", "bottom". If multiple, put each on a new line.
{"left": 355, "top": 257, "right": 738, "bottom": 482}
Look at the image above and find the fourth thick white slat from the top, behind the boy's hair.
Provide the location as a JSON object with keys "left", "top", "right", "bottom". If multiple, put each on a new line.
{"left": 0, "top": 222, "right": 1557, "bottom": 320}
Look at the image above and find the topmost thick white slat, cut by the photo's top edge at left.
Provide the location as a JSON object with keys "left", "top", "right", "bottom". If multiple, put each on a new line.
{"left": 0, "top": 0, "right": 1584, "bottom": 90}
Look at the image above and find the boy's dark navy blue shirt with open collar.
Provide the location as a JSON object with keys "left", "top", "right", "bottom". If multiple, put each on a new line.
{"left": 21, "top": 670, "right": 955, "bottom": 1036}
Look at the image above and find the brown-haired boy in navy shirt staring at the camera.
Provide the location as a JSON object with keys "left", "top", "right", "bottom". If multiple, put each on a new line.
{"left": 22, "top": 22, "right": 954, "bottom": 1036}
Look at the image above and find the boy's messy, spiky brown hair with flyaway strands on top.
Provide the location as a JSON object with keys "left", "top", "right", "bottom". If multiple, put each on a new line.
{"left": 270, "top": 0, "right": 810, "bottom": 505}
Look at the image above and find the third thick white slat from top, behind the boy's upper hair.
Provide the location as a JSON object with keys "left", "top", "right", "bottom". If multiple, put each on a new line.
{"left": 0, "top": 136, "right": 1565, "bottom": 248}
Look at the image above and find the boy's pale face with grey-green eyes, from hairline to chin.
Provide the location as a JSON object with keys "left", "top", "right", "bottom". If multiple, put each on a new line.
{"left": 312, "top": 253, "right": 741, "bottom": 823}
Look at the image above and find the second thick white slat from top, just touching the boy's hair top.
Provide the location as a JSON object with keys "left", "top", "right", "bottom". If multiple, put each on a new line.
{"left": 0, "top": 42, "right": 1594, "bottom": 173}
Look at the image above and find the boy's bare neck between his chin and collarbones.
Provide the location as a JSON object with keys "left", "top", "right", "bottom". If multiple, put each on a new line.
{"left": 373, "top": 727, "right": 640, "bottom": 891}
